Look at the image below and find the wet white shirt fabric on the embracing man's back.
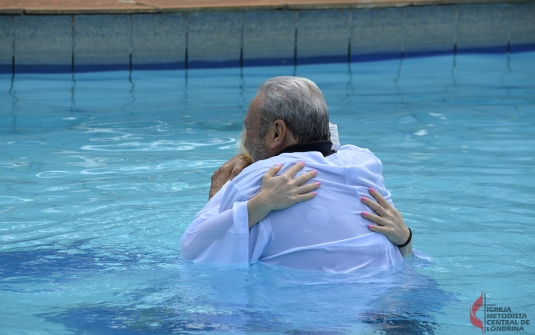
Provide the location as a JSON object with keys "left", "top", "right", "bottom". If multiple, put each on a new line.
{"left": 180, "top": 145, "right": 402, "bottom": 273}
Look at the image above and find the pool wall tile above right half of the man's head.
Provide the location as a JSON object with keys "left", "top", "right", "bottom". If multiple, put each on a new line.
{"left": 296, "top": 10, "right": 351, "bottom": 64}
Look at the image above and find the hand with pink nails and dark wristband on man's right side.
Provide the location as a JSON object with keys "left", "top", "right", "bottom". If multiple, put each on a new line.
{"left": 361, "top": 188, "right": 412, "bottom": 257}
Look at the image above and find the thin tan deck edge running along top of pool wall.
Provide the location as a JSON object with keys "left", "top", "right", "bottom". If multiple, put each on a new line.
{"left": 0, "top": 0, "right": 530, "bottom": 15}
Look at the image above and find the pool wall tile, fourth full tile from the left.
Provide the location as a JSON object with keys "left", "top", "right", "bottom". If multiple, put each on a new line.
{"left": 187, "top": 11, "right": 242, "bottom": 68}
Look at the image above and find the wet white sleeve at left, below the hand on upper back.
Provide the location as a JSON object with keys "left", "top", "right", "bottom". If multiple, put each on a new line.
{"left": 180, "top": 182, "right": 268, "bottom": 265}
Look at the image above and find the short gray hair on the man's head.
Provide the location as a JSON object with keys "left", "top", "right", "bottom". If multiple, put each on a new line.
{"left": 258, "top": 77, "right": 331, "bottom": 144}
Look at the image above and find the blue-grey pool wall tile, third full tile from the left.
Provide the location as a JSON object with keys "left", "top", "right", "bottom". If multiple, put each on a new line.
{"left": 132, "top": 13, "right": 186, "bottom": 69}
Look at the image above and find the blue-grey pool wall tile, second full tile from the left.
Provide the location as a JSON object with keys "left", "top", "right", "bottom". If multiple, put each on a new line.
{"left": 74, "top": 15, "right": 130, "bottom": 72}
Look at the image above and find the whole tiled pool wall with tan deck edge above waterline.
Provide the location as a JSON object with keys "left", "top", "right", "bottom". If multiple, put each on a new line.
{"left": 0, "top": 0, "right": 535, "bottom": 75}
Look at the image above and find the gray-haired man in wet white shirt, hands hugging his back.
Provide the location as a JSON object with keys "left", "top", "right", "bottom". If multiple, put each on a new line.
{"left": 180, "top": 77, "right": 412, "bottom": 273}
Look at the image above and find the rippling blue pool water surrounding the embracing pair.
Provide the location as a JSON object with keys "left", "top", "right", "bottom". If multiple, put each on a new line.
{"left": 0, "top": 52, "right": 535, "bottom": 334}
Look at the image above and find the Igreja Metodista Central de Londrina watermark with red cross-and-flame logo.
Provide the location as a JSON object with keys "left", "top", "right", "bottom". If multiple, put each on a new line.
{"left": 470, "top": 292, "right": 530, "bottom": 334}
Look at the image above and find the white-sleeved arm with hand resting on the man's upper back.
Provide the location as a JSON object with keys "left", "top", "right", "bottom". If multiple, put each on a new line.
{"left": 180, "top": 163, "right": 319, "bottom": 264}
